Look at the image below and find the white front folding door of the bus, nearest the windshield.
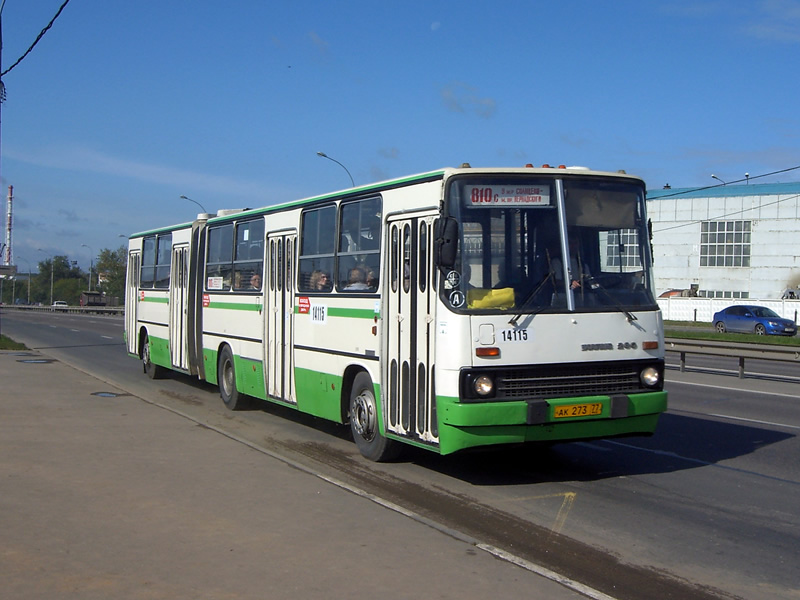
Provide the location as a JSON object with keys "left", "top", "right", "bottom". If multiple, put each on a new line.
{"left": 383, "top": 214, "right": 439, "bottom": 443}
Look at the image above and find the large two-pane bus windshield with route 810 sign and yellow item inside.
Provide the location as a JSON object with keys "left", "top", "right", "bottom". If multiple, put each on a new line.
{"left": 440, "top": 175, "right": 657, "bottom": 312}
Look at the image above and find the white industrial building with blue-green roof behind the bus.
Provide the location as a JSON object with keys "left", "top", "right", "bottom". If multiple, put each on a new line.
{"left": 647, "top": 181, "right": 800, "bottom": 299}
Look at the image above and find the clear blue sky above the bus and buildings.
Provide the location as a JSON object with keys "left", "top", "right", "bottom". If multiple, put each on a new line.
{"left": 0, "top": 0, "right": 800, "bottom": 270}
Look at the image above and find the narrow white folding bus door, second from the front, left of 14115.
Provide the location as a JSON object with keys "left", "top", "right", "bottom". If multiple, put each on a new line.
{"left": 264, "top": 232, "right": 297, "bottom": 404}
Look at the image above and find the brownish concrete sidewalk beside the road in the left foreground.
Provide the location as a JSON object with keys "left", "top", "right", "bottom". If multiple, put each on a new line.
{"left": 0, "top": 351, "right": 584, "bottom": 600}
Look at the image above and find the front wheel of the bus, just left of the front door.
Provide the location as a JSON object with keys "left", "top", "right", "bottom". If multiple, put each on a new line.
{"left": 350, "top": 371, "right": 401, "bottom": 462}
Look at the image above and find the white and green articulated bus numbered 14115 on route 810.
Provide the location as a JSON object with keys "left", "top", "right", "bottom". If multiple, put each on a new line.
{"left": 125, "top": 164, "right": 667, "bottom": 460}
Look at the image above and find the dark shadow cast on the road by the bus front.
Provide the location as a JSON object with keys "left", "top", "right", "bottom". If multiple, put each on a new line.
{"left": 407, "top": 413, "right": 796, "bottom": 485}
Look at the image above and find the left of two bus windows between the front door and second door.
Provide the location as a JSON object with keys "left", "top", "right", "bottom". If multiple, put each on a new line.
{"left": 297, "top": 205, "right": 336, "bottom": 292}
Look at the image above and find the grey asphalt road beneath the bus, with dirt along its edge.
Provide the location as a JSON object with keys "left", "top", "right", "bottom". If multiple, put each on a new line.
{"left": 2, "top": 311, "right": 800, "bottom": 600}
